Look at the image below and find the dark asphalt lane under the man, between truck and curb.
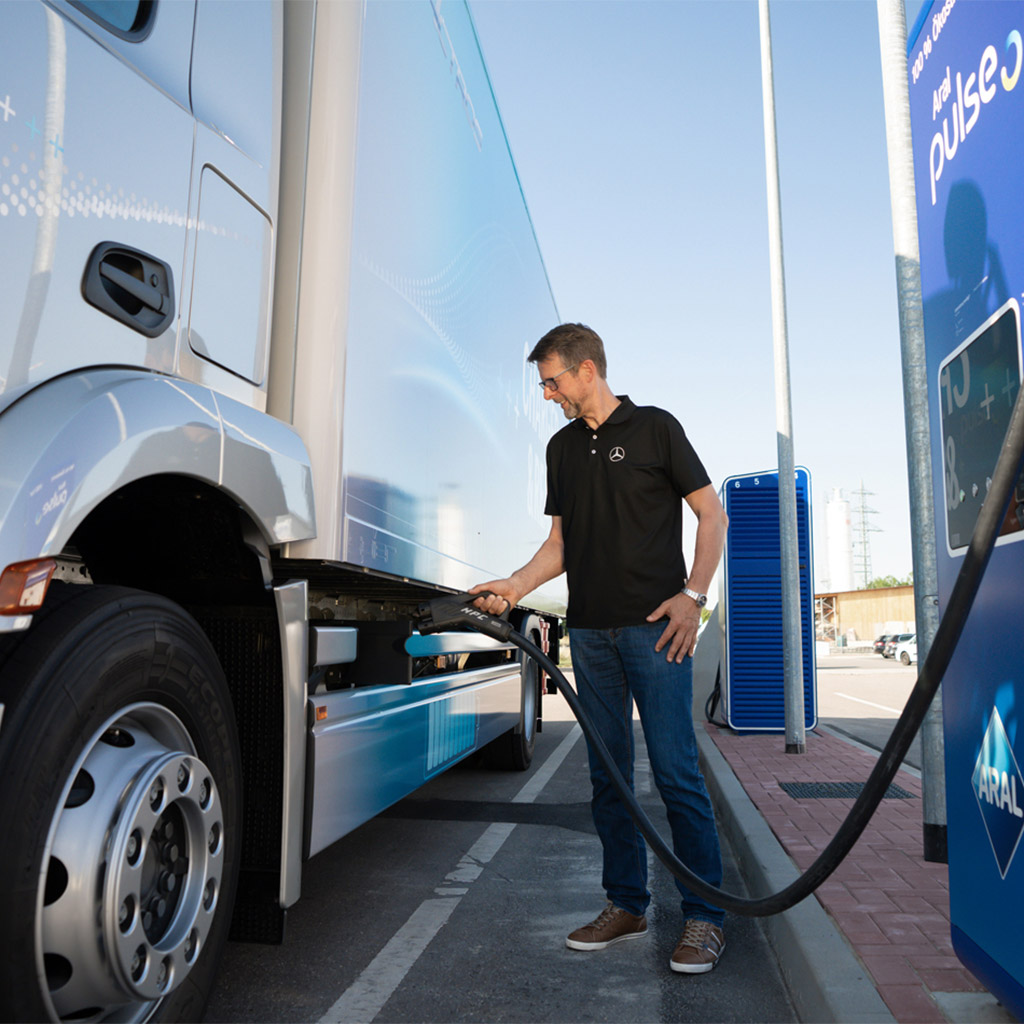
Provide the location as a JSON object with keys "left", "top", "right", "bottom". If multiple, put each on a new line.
{"left": 207, "top": 696, "right": 796, "bottom": 1024}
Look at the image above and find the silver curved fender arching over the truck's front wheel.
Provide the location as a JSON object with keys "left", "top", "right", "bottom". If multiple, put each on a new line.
{"left": 0, "top": 369, "right": 315, "bottom": 614}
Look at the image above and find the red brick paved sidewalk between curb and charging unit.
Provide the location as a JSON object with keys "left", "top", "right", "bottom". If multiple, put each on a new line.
{"left": 707, "top": 725, "right": 1012, "bottom": 1024}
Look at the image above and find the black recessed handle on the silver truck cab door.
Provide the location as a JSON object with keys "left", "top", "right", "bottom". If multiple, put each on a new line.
{"left": 82, "top": 242, "right": 174, "bottom": 338}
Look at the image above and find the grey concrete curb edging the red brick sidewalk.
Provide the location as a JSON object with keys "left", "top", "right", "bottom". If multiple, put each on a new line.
{"left": 694, "top": 719, "right": 895, "bottom": 1024}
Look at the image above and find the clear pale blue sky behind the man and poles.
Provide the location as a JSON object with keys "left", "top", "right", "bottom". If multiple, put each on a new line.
{"left": 470, "top": 0, "right": 920, "bottom": 589}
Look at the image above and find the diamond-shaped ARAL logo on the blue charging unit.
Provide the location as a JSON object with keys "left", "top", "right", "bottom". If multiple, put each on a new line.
{"left": 971, "top": 708, "right": 1024, "bottom": 879}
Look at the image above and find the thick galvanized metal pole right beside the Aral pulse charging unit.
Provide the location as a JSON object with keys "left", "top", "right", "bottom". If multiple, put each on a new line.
{"left": 878, "top": 0, "right": 947, "bottom": 863}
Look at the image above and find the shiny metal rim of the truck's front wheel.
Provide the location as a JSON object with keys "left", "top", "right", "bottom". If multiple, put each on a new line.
{"left": 36, "top": 703, "right": 224, "bottom": 1021}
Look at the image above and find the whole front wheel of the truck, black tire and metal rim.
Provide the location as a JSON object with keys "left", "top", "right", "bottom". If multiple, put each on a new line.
{"left": 0, "top": 584, "right": 241, "bottom": 1021}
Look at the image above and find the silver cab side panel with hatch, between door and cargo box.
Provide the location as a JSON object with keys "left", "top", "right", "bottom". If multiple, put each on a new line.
{"left": 178, "top": 0, "right": 282, "bottom": 410}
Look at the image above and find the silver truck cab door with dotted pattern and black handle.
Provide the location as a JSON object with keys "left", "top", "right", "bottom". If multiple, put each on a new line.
{"left": 0, "top": 0, "right": 195, "bottom": 408}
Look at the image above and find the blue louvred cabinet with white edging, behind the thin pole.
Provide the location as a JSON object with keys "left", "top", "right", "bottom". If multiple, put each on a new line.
{"left": 719, "top": 468, "right": 815, "bottom": 733}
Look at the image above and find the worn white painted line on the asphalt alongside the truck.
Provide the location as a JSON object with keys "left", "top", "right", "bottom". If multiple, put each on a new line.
{"left": 318, "top": 725, "right": 583, "bottom": 1024}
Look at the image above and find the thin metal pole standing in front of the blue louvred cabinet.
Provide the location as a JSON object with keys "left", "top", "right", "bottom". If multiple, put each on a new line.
{"left": 758, "top": 0, "right": 807, "bottom": 754}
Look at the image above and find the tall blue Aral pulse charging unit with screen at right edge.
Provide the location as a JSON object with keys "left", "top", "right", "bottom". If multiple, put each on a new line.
{"left": 907, "top": 0, "right": 1024, "bottom": 1020}
